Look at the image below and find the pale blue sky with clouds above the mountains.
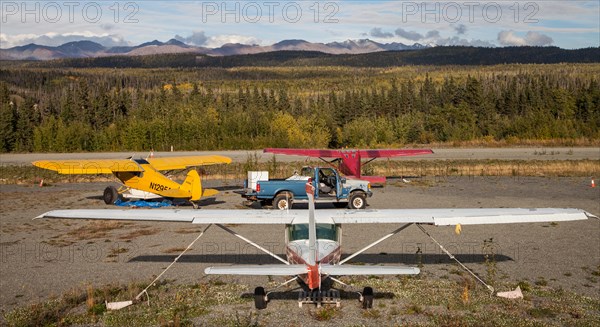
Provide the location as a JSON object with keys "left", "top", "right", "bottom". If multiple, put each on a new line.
{"left": 0, "top": 0, "right": 600, "bottom": 49}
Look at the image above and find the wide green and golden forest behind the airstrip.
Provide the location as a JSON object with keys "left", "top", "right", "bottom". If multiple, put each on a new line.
{"left": 0, "top": 65, "right": 600, "bottom": 152}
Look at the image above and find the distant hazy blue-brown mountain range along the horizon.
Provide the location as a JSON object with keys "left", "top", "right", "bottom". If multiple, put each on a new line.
{"left": 0, "top": 39, "right": 431, "bottom": 60}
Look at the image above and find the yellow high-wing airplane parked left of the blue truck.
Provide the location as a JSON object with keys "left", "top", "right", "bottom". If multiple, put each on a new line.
{"left": 32, "top": 155, "right": 231, "bottom": 207}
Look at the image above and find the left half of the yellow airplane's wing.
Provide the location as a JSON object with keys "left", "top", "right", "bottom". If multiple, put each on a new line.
{"left": 32, "top": 159, "right": 144, "bottom": 174}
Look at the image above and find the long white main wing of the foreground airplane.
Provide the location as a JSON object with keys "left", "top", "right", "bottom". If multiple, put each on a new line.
{"left": 37, "top": 208, "right": 595, "bottom": 226}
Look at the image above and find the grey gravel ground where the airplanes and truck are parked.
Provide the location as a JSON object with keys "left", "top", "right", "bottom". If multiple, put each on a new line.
{"left": 0, "top": 177, "right": 600, "bottom": 322}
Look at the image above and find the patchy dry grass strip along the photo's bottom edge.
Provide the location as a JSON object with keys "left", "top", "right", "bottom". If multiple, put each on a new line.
{"left": 4, "top": 277, "right": 600, "bottom": 326}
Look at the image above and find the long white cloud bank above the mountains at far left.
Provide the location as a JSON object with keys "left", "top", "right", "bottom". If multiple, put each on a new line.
{"left": 0, "top": 31, "right": 129, "bottom": 49}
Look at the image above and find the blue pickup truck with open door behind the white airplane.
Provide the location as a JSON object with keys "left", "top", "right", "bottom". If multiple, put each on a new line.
{"left": 241, "top": 167, "right": 373, "bottom": 210}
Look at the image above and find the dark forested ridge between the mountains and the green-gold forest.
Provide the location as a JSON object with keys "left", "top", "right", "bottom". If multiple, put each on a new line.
{"left": 19, "top": 45, "right": 600, "bottom": 68}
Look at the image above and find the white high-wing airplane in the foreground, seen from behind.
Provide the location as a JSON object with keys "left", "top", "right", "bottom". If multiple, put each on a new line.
{"left": 37, "top": 184, "right": 595, "bottom": 309}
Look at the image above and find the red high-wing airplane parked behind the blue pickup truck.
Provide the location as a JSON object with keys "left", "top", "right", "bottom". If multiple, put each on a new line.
{"left": 264, "top": 148, "right": 433, "bottom": 184}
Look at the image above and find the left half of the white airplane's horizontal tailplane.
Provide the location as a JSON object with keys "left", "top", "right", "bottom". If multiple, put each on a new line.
{"left": 204, "top": 264, "right": 307, "bottom": 276}
